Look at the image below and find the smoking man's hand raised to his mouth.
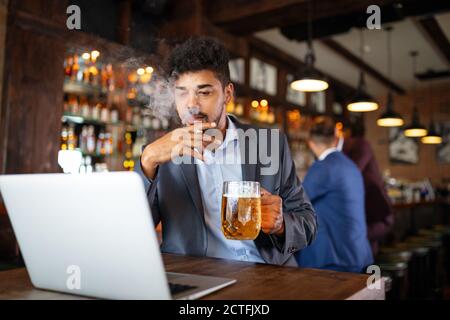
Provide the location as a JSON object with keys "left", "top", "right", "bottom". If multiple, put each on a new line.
{"left": 141, "top": 122, "right": 216, "bottom": 179}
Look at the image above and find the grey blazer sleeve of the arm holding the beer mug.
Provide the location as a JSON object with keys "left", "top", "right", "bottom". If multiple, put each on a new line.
{"left": 271, "top": 135, "right": 317, "bottom": 255}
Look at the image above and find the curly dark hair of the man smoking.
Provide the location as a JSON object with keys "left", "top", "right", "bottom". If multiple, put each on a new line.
{"left": 169, "top": 37, "right": 230, "bottom": 86}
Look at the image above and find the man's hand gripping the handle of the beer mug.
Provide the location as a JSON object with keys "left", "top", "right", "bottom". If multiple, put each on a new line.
{"left": 261, "top": 188, "right": 284, "bottom": 236}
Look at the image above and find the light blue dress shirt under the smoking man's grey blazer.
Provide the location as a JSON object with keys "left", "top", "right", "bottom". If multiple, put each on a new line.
{"left": 195, "top": 117, "right": 265, "bottom": 263}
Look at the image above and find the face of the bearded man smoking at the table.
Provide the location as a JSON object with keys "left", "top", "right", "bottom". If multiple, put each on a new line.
{"left": 175, "top": 70, "right": 233, "bottom": 126}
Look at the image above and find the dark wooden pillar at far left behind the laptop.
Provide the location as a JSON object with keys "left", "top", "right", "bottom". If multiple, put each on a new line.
{"left": 0, "top": 0, "right": 67, "bottom": 260}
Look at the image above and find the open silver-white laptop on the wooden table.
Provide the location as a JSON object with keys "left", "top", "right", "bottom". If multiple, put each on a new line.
{"left": 0, "top": 172, "right": 236, "bottom": 299}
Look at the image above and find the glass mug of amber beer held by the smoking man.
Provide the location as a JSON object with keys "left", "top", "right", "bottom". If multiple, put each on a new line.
{"left": 222, "top": 181, "right": 261, "bottom": 240}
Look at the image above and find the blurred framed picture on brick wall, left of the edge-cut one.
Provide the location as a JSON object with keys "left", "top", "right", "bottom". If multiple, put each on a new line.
{"left": 389, "top": 128, "right": 419, "bottom": 164}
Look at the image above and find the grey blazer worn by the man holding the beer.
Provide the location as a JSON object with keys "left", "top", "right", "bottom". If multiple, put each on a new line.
{"left": 136, "top": 117, "right": 317, "bottom": 266}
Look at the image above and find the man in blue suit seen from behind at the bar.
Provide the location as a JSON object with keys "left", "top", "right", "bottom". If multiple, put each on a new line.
{"left": 296, "top": 117, "right": 373, "bottom": 272}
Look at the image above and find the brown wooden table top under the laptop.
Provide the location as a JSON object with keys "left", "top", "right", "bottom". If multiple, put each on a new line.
{"left": 0, "top": 254, "right": 385, "bottom": 300}
